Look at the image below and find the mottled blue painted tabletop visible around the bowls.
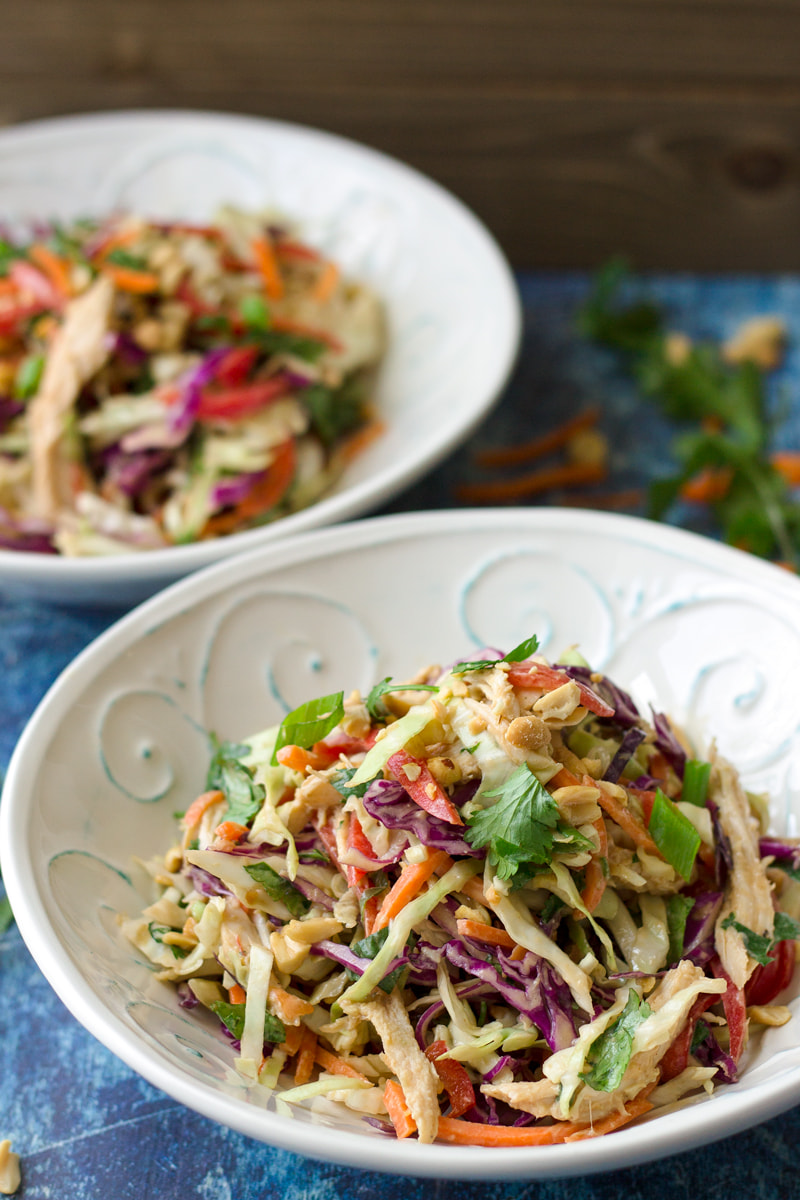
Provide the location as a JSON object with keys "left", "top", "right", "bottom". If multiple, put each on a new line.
{"left": 0, "top": 274, "right": 800, "bottom": 1200}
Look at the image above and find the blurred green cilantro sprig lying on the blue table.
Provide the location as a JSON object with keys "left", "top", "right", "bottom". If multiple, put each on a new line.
{"left": 578, "top": 260, "right": 800, "bottom": 569}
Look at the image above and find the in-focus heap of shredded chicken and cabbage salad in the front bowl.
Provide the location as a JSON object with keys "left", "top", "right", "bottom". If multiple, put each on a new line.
{"left": 122, "top": 637, "right": 800, "bottom": 1146}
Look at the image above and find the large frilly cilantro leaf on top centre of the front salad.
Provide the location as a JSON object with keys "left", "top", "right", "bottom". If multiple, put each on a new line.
{"left": 465, "top": 763, "right": 560, "bottom": 880}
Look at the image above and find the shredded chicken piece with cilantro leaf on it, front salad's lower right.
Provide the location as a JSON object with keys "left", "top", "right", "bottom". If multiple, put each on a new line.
{"left": 481, "top": 959, "right": 727, "bottom": 1123}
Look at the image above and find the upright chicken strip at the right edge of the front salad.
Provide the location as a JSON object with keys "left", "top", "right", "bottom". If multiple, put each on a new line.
{"left": 709, "top": 754, "right": 775, "bottom": 988}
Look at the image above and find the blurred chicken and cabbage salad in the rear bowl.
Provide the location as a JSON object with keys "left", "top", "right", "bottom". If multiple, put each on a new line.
{"left": 0, "top": 209, "right": 385, "bottom": 556}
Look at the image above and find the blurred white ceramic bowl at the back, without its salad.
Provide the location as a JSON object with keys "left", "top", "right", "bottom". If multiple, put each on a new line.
{"left": 0, "top": 112, "right": 521, "bottom": 605}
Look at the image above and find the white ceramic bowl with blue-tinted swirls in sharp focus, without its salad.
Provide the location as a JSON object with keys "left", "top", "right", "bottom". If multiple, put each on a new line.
{"left": 0, "top": 509, "right": 800, "bottom": 1178}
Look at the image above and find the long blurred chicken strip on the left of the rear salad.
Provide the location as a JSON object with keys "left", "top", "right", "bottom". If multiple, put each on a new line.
{"left": 28, "top": 276, "right": 114, "bottom": 520}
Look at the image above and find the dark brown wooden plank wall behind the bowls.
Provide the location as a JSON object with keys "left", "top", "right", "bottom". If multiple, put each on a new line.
{"left": 0, "top": 0, "right": 800, "bottom": 271}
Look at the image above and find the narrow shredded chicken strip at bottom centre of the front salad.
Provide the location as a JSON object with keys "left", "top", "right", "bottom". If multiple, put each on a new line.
{"left": 342, "top": 992, "right": 439, "bottom": 1142}
